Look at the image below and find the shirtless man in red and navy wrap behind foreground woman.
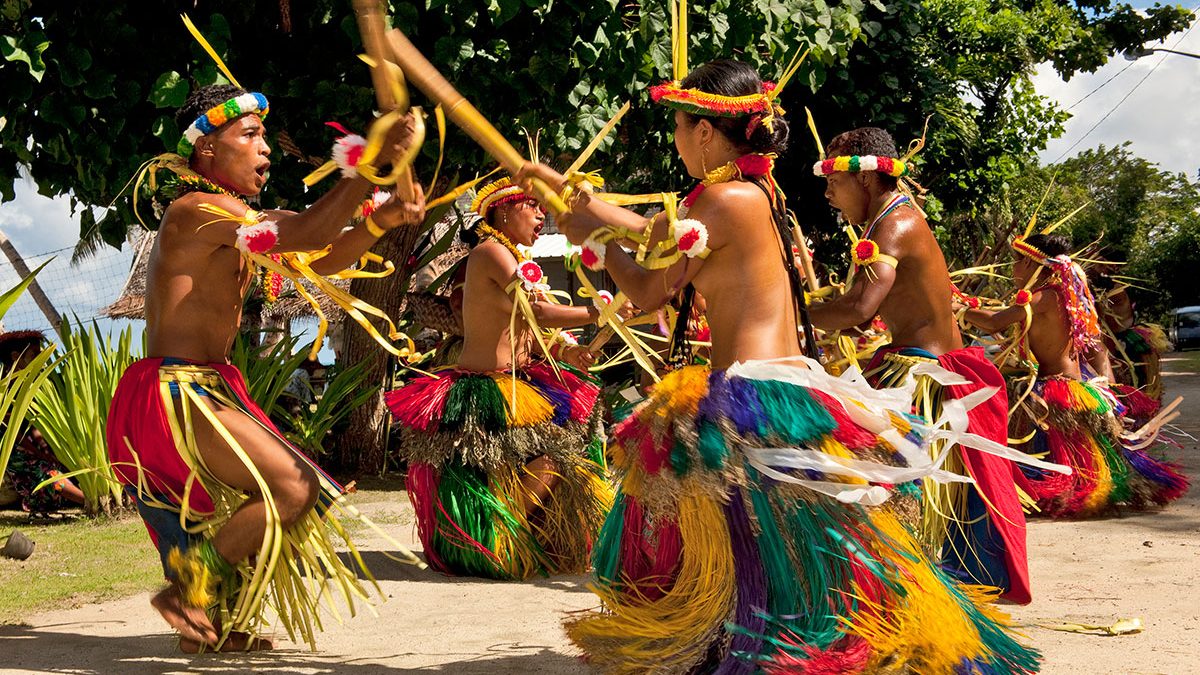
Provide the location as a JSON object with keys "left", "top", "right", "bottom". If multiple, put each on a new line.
{"left": 811, "top": 127, "right": 1030, "bottom": 603}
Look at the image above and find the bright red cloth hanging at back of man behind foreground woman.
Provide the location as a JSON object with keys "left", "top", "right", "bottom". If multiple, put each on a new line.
{"left": 866, "top": 346, "right": 1032, "bottom": 604}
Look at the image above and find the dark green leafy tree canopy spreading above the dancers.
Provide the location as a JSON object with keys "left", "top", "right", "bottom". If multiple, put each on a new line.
{"left": 0, "top": 0, "right": 1190, "bottom": 258}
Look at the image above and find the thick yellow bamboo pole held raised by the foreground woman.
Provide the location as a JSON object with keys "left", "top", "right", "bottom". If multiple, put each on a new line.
{"left": 386, "top": 29, "right": 569, "bottom": 215}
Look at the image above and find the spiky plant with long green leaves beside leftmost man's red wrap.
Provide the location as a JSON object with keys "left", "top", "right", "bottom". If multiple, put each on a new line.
{"left": 30, "top": 321, "right": 137, "bottom": 515}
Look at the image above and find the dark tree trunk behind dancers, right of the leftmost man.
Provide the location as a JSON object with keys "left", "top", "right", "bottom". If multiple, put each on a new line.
{"left": 338, "top": 226, "right": 422, "bottom": 474}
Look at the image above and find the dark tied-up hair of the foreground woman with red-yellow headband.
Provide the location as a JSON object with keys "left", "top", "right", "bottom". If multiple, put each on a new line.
{"left": 679, "top": 59, "right": 787, "bottom": 155}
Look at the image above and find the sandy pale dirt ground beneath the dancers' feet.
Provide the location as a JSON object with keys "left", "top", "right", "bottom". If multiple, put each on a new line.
{"left": 0, "top": 359, "right": 1200, "bottom": 675}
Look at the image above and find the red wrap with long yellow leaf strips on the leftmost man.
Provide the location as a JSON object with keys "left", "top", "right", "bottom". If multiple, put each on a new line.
{"left": 107, "top": 358, "right": 388, "bottom": 649}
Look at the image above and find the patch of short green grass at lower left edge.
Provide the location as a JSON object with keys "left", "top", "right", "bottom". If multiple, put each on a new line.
{"left": 0, "top": 513, "right": 162, "bottom": 625}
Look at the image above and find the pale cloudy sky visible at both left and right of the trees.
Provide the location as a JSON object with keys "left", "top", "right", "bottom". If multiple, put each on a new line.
{"left": 0, "top": 10, "right": 1200, "bottom": 348}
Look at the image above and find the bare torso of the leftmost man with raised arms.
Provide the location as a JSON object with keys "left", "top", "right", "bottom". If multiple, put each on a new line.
{"left": 145, "top": 192, "right": 251, "bottom": 363}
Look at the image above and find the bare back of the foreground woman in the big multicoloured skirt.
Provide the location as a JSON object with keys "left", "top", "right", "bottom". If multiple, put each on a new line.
{"left": 692, "top": 183, "right": 800, "bottom": 369}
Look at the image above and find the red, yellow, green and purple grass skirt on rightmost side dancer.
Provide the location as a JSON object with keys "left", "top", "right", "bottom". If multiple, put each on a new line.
{"left": 1010, "top": 376, "right": 1188, "bottom": 518}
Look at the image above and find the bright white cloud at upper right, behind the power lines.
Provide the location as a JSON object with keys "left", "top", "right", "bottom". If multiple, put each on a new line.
{"left": 1033, "top": 19, "right": 1200, "bottom": 178}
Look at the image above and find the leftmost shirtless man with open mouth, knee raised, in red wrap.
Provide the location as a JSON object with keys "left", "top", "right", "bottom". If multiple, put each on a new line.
{"left": 107, "top": 85, "right": 424, "bottom": 651}
